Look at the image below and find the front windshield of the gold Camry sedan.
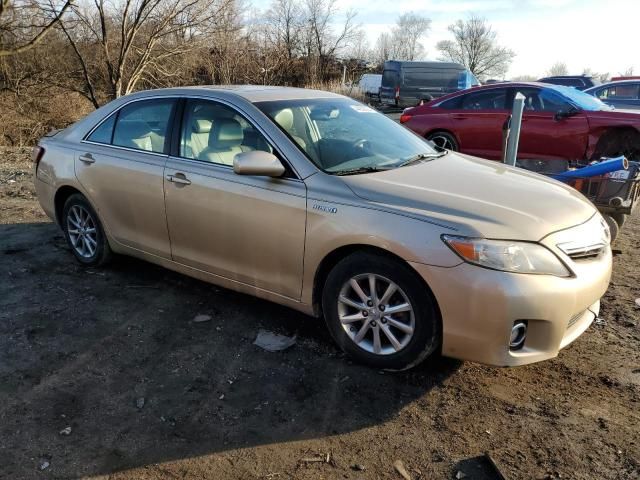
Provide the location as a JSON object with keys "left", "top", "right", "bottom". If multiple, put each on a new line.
{"left": 256, "top": 98, "right": 442, "bottom": 175}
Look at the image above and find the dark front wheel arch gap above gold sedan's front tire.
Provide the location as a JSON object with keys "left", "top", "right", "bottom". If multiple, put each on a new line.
{"left": 312, "top": 244, "right": 442, "bottom": 331}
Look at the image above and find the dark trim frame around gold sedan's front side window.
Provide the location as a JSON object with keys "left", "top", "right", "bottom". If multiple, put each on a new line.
{"left": 169, "top": 95, "right": 302, "bottom": 181}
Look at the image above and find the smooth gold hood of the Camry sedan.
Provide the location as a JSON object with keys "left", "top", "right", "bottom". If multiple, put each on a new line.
{"left": 341, "top": 153, "right": 596, "bottom": 241}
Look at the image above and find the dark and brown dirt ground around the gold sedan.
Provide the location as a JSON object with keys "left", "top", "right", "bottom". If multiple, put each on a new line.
{"left": 0, "top": 150, "right": 640, "bottom": 480}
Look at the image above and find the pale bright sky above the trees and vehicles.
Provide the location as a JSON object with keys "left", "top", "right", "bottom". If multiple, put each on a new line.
{"left": 254, "top": 0, "right": 640, "bottom": 77}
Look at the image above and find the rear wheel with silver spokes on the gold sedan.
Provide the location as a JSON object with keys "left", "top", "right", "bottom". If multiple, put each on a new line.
{"left": 61, "top": 193, "right": 111, "bottom": 267}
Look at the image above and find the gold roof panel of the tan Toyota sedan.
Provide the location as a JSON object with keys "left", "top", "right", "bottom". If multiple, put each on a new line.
{"left": 123, "top": 85, "right": 344, "bottom": 103}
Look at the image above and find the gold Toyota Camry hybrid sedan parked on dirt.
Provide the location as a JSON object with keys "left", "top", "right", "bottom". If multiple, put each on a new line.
{"left": 33, "top": 86, "right": 611, "bottom": 370}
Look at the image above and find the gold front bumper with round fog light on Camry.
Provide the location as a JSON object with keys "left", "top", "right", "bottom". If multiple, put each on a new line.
{"left": 412, "top": 247, "right": 611, "bottom": 366}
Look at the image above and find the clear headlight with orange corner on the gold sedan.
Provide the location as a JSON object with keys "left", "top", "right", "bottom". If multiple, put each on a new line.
{"left": 442, "top": 235, "right": 571, "bottom": 277}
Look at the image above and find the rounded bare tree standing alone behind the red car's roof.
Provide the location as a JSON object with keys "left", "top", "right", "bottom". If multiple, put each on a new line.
{"left": 437, "top": 16, "right": 515, "bottom": 78}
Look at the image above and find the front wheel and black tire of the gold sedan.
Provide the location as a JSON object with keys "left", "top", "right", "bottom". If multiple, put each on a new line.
{"left": 322, "top": 253, "right": 441, "bottom": 370}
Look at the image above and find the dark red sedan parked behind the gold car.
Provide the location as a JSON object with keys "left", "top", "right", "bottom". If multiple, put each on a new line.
{"left": 400, "top": 83, "right": 640, "bottom": 169}
